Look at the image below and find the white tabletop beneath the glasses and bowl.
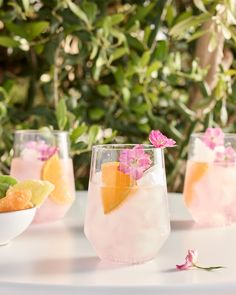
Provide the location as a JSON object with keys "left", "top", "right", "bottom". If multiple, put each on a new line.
{"left": 0, "top": 192, "right": 236, "bottom": 295}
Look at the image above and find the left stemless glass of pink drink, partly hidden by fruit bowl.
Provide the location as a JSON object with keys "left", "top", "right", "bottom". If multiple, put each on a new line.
{"left": 10, "top": 130, "right": 75, "bottom": 222}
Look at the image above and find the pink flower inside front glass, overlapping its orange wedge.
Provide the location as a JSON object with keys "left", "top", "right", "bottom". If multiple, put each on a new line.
{"left": 119, "top": 144, "right": 152, "bottom": 180}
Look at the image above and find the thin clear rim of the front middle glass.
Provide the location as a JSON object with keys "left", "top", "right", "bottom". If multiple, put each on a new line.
{"left": 93, "top": 143, "right": 159, "bottom": 151}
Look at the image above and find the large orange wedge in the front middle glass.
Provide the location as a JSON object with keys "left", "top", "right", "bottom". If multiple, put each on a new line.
{"left": 101, "top": 162, "right": 135, "bottom": 214}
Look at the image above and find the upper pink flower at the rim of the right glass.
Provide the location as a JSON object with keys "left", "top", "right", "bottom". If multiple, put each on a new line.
{"left": 202, "top": 128, "right": 224, "bottom": 150}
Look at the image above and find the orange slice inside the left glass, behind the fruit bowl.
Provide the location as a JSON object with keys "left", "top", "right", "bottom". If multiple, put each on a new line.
{"left": 41, "top": 153, "right": 74, "bottom": 205}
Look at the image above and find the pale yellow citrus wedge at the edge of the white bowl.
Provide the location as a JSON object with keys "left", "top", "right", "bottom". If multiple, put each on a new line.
{"left": 10, "top": 180, "right": 54, "bottom": 206}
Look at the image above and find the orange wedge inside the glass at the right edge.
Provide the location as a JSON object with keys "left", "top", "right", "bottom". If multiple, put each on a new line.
{"left": 184, "top": 162, "right": 208, "bottom": 206}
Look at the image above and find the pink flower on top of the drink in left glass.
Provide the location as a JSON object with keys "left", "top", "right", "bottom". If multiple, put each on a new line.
{"left": 26, "top": 140, "right": 58, "bottom": 161}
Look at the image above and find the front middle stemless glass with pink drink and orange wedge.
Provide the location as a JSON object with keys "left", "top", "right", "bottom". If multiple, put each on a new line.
{"left": 85, "top": 144, "right": 170, "bottom": 264}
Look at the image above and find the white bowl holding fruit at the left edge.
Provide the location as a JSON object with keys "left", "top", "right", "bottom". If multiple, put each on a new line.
{"left": 0, "top": 207, "right": 36, "bottom": 246}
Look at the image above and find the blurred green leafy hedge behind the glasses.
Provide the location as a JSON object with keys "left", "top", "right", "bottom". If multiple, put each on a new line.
{"left": 0, "top": 0, "right": 236, "bottom": 191}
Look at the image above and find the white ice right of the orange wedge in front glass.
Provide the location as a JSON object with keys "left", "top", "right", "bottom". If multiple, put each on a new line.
{"left": 137, "top": 165, "right": 166, "bottom": 186}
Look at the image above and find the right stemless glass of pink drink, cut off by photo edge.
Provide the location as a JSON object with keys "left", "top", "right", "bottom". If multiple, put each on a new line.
{"left": 184, "top": 133, "right": 236, "bottom": 226}
